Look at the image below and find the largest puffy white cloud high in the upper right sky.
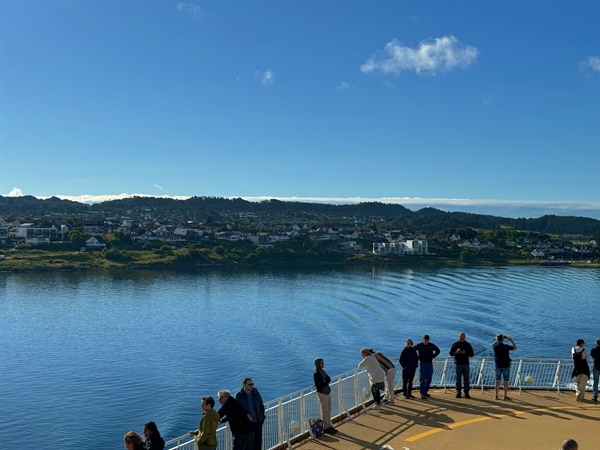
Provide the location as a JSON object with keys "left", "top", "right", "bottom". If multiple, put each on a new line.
{"left": 360, "top": 35, "right": 477, "bottom": 75}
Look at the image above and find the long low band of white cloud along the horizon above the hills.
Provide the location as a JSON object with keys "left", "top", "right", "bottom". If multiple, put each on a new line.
{"left": 38, "top": 193, "right": 600, "bottom": 219}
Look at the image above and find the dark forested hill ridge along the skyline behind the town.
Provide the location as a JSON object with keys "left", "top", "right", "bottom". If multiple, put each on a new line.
{"left": 0, "top": 196, "right": 600, "bottom": 236}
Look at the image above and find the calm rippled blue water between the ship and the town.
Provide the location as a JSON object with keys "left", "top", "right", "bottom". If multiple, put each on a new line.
{"left": 0, "top": 267, "right": 600, "bottom": 450}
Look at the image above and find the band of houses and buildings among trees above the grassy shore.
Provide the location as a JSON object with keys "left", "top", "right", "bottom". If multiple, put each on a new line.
{"left": 0, "top": 213, "right": 595, "bottom": 259}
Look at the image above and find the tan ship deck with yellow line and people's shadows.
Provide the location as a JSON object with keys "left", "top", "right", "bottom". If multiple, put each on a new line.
{"left": 294, "top": 389, "right": 600, "bottom": 450}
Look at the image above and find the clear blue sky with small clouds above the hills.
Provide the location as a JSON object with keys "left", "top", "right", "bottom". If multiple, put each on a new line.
{"left": 0, "top": 0, "right": 600, "bottom": 218}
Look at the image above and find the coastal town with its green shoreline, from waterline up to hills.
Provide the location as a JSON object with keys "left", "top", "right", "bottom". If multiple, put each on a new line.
{"left": 0, "top": 196, "right": 600, "bottom": 270}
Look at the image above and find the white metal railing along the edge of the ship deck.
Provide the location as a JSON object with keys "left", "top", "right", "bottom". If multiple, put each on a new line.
{"left": 165, "top": 357, "right": 592, "bottom": 450}
